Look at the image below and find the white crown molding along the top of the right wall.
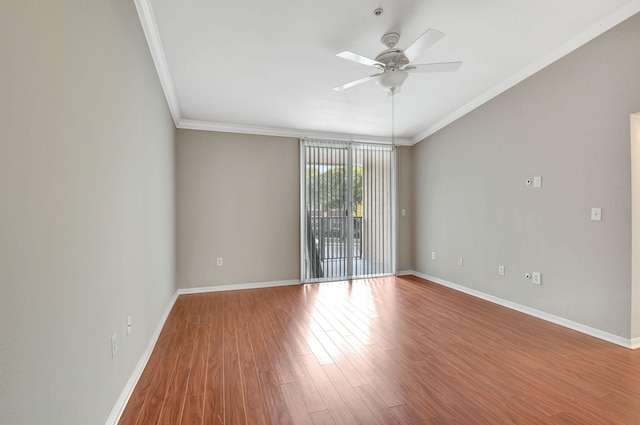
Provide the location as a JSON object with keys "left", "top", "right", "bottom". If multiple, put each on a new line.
{"left": 411, "top": 0, "right": 640, "bottom": 145}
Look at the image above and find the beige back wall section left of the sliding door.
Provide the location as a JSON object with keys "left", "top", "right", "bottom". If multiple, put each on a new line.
{"left": 176, "top": 130, "right": 300, "bottom": 288}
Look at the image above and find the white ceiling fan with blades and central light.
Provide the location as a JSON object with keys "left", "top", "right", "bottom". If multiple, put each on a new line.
{"left": 334, "top": 28, "right": 462, "bottom": 93}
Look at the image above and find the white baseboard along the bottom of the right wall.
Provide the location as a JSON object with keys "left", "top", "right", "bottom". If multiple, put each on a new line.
{"left": 406, "top": 270, "right": 640, "bottom": 349}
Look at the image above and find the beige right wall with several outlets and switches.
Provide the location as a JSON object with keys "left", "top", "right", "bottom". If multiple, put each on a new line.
{"left": 412, "top": 15, "right": 640, "bottom": 338}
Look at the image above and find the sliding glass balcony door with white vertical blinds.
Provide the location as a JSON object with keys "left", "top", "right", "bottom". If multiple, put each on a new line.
{"left": 300, "top": 140, "right": 395, "bottom": 282}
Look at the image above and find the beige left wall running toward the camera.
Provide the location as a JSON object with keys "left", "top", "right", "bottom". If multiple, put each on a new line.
{"left": 0, "top": 0, "right": 175, "bottom": 425}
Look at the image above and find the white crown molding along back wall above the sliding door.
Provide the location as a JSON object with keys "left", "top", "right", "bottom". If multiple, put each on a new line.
{"left": 176, "top": 119, "right": 412, "bottom": 146}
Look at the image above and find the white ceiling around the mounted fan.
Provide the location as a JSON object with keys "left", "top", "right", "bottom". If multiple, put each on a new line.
{"left": 136, "top": 0, "right": 640, "bottom": 144}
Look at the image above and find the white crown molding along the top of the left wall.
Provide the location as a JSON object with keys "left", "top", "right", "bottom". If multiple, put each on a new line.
{"left": 134, "top": 0, "right": 182, "bottom": 127}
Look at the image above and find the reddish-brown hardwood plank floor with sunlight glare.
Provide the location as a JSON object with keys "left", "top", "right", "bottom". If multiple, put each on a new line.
{"left": 119, "top": 277, "right": 640, "bottom": 425}
